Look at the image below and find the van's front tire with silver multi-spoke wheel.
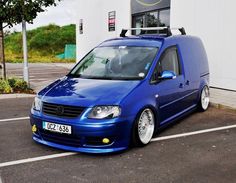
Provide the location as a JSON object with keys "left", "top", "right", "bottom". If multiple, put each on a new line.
{"left": 132, "top": 108, "right": 155, "bottom": 147}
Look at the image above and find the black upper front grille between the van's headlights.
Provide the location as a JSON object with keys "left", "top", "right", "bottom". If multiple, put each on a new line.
{"left": 42, "top": 102, "right": 84, "bottom": 118}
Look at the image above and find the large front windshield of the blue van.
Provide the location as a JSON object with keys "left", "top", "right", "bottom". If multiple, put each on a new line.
{"left": 69, "top": 46, "right": 158, "bottom": 80}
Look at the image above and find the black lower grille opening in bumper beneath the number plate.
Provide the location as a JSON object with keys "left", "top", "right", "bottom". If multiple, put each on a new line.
{"left": 39, "top": 129, "right": 81, "bottom": 147}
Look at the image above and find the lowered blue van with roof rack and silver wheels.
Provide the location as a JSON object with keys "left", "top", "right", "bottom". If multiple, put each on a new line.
{"left": 30, "top": 28, "right": 209, "bottom": 153}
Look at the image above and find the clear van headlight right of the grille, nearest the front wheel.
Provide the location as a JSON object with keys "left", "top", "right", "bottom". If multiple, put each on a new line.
{"left": 88, "top": 106, "right": 121, "bottom": 119}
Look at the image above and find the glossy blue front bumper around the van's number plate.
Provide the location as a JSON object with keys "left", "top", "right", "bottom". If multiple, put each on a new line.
{"left": 30, "top": 114, "right": 134, "bottom": 153}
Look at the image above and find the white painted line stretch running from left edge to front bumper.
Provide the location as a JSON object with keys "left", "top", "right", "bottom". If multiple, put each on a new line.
{"left": 0, "top": 152, "right": 77, "bottom": 168}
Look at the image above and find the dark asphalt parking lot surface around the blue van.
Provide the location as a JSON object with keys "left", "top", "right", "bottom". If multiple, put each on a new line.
{"left": 0, "top": 98, "right": 236, "bottom": 183}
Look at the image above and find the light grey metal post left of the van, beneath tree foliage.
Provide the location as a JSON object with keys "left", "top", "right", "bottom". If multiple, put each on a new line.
{"left": 22, "top": 20, "right": 30, "bottom": 86}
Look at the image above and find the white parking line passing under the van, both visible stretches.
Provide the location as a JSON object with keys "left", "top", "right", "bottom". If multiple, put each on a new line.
{"left": 0, "top": 125, "right": 236, "bottom": 168}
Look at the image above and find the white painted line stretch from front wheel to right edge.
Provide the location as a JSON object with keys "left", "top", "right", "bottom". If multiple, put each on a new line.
{"left": 151, "top": 125, "right": 236, "bottom": 142}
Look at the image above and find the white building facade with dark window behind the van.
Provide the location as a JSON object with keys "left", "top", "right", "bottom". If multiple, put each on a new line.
{"left": 75, "top": 0, "right": 236, "bottom": 91}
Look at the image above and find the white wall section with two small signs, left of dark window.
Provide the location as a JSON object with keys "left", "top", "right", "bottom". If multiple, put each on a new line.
{"left": 76, "top": 0, "right": 131, "bottom": 61}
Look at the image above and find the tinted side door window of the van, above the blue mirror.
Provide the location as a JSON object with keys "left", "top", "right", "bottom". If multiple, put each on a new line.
{"left": 157, "top": 47, "right": 181, "bottom": 76}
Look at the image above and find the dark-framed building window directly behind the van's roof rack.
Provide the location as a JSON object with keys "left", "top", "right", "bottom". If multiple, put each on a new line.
{"left": 133, "top": 9, "right": 170, "bottom": 35}
